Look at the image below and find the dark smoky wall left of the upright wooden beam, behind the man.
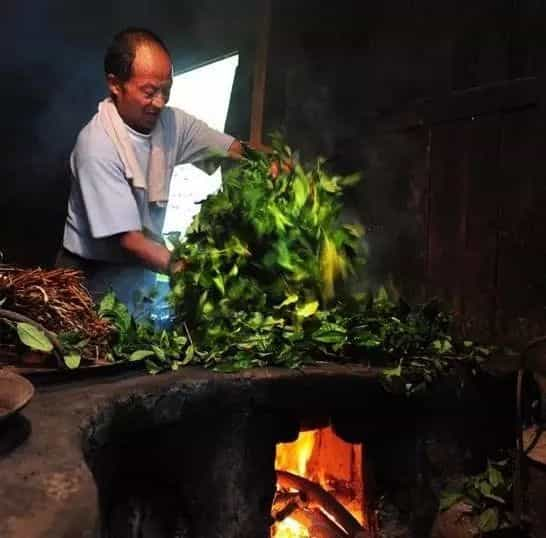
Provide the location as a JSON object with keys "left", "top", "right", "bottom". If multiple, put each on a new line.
{"left": 0, "top": 0, "right": 256, "bottom": 266}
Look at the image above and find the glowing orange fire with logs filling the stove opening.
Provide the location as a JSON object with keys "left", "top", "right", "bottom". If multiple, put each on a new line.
{"left": 271, "top": 427, "right": 367, "bottom": 538}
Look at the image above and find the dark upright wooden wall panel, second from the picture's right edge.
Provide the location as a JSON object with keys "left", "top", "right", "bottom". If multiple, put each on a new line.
{"left": 427, "top": 117, "right": 499, "bottom": 340}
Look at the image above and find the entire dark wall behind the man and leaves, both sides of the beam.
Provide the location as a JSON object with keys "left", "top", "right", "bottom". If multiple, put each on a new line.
{"left": 0, "top": 0, "right": 546, "bottom": 342}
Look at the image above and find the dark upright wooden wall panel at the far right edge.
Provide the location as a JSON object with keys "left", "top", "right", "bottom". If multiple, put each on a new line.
{"left": 496, "top": 105, "right": 546, "bottom": 345}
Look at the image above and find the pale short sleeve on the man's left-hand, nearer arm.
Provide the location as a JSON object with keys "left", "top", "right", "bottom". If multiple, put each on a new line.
{"left": 73, "top": 155, "right": 142, "bottom": 239}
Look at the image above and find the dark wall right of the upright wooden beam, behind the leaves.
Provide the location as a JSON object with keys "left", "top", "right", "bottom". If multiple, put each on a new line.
{"left": 266, "top": 0, "right": 546, "bottom": 343}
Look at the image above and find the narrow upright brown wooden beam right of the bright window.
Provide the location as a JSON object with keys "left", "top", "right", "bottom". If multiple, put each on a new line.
{"left": 250, "top": 0, "right": 271, "bottom": 148}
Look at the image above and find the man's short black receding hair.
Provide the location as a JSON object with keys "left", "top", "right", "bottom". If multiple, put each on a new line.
{"left": 104, "top": 28, "right": 170, "bottom": 82}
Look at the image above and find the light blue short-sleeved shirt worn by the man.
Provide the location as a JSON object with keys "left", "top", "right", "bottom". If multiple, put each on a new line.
{"left": 63, "top": 103, "right": 234, "bottom": 263}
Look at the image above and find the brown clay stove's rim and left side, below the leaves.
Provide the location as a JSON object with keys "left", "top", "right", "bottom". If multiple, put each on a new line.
{"left": 0, "top": 365, "right": 382, "bottom": 538}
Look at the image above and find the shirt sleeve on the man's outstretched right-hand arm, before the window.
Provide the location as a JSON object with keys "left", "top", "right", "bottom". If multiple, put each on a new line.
{"left": 175, "top": 109, "right": 235, "bottom": 164}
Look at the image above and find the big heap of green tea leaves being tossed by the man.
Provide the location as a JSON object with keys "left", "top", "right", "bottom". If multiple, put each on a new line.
{"left": 151, "top": 139, "right": 486, "bottom": 392}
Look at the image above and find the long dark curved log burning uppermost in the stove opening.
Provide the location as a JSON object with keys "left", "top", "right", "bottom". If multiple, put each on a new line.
{"left": 277, "top": 471, "right": 369, "bottom": 538}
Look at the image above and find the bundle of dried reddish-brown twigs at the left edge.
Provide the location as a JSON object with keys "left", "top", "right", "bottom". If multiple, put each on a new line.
{"left": 0, "top": 265, "right": 112, "bottom": 358}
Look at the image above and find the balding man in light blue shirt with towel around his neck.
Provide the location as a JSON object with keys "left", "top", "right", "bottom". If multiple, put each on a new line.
{"left": 57, "top": 28, "right": 243, "bottom": 303}
